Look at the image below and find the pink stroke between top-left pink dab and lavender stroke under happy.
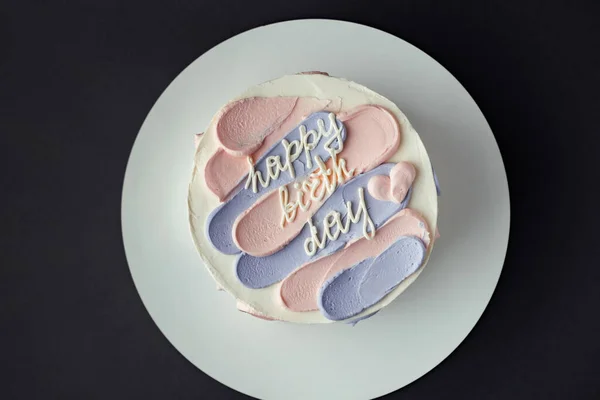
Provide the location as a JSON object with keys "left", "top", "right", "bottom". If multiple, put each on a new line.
{"left": 204, "top": 97, "right": 331, "bottom": 201}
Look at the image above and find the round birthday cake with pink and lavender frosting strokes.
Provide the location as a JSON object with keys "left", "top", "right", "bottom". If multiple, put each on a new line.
{"left": 188, "top": 72, "right": 438, "bottom": 323}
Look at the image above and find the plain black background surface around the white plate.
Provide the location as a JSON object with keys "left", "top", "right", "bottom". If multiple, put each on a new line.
{"left": 0, "top": 0, "right": 600, "bottom": 399}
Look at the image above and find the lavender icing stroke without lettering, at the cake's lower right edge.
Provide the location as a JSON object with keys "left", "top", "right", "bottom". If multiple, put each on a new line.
{"left": 318, "top": 236, "right": 425, "bottom": 321}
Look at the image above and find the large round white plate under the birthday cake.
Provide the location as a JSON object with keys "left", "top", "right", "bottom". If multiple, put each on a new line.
{"left": 122, "top": 20, "right": 510, "bottom": 400}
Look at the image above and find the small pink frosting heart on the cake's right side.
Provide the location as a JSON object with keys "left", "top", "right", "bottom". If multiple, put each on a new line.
{"left": 367, "top": 161, "right": 417, "bottom": 203}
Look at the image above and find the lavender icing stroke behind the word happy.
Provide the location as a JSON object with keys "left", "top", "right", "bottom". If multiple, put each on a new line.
{"left": 206, "top": 111, "right": 346, "bottom": 254}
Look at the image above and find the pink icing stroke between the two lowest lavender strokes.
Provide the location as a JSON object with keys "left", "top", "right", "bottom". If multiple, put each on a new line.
{"left": 280, "top": 208, "right": 430, "bottom": 312}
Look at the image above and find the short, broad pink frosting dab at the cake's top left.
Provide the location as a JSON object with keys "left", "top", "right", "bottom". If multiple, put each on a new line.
{"left": 216, "top": 97, "right": 298, "bottom": 157}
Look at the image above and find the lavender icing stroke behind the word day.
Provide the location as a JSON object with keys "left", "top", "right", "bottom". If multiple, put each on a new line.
{"left": 235, "top": 163, "right": 412, "bottom": 289}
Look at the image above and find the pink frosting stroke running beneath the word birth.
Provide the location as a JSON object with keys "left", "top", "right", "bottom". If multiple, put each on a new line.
{"left": 233, "top": 105, "right": 400, "bottom": 257}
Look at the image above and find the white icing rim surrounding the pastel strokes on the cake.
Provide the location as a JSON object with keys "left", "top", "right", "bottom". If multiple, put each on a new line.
{"left": 188, "top": 75, "right": 438, "bottom": 323}
